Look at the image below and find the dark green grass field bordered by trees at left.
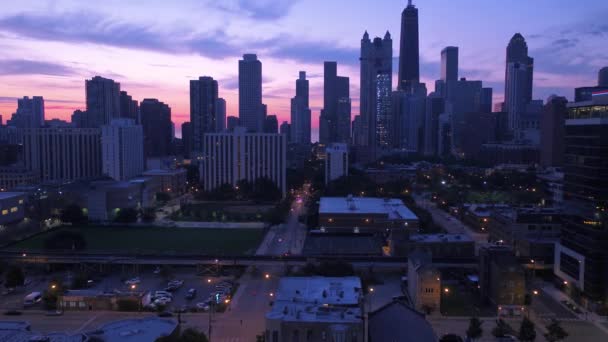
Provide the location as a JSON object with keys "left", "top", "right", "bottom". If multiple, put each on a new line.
{"left": 8, "top": 227, "right": 264, "bottom": 255}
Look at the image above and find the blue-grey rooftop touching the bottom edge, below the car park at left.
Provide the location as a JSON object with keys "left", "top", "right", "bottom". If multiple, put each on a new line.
{"left": 87, "top": 317, "right": 177, "bottom": 342}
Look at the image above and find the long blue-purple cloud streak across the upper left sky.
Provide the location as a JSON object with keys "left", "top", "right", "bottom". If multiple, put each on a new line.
{"left": 0, "top": 11, "right": 238, "bottom": 58}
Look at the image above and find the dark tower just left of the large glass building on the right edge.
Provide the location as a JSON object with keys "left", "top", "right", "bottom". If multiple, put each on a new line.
{"left": 540, "top": 95, "right": 568, "bottom": 167}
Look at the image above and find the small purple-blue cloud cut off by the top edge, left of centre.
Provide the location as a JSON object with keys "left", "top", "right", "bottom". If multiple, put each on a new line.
{"left": 208, "top": 0, "right": 298, "bottom": 21}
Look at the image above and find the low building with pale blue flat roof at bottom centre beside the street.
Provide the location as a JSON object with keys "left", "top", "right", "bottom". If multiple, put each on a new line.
{"left": 265, "top": 277, "right": 365, "bottom": 342}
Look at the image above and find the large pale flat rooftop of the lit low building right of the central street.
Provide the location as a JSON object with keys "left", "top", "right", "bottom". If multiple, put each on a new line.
{"left": 319, "top": 196, "right": 418, "bottom": 220}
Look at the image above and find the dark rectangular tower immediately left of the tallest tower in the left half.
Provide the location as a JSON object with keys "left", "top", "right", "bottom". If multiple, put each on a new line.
{"left": 190, "top": 76, "right": 218, "bottom": 152}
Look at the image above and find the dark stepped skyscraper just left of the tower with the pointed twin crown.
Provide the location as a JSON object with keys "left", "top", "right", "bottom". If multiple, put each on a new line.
{"left": 319, "top": 62, "right": 350, "bottom": 144}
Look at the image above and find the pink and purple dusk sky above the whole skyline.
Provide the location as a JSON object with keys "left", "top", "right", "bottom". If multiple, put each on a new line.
{"left": 0, "top": 0, "right": 608, "bottom": 140}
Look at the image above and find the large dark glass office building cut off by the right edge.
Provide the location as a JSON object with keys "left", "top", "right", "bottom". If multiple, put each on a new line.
{"left": 553, "top": 91, "right": 608, "bottom": 310}
